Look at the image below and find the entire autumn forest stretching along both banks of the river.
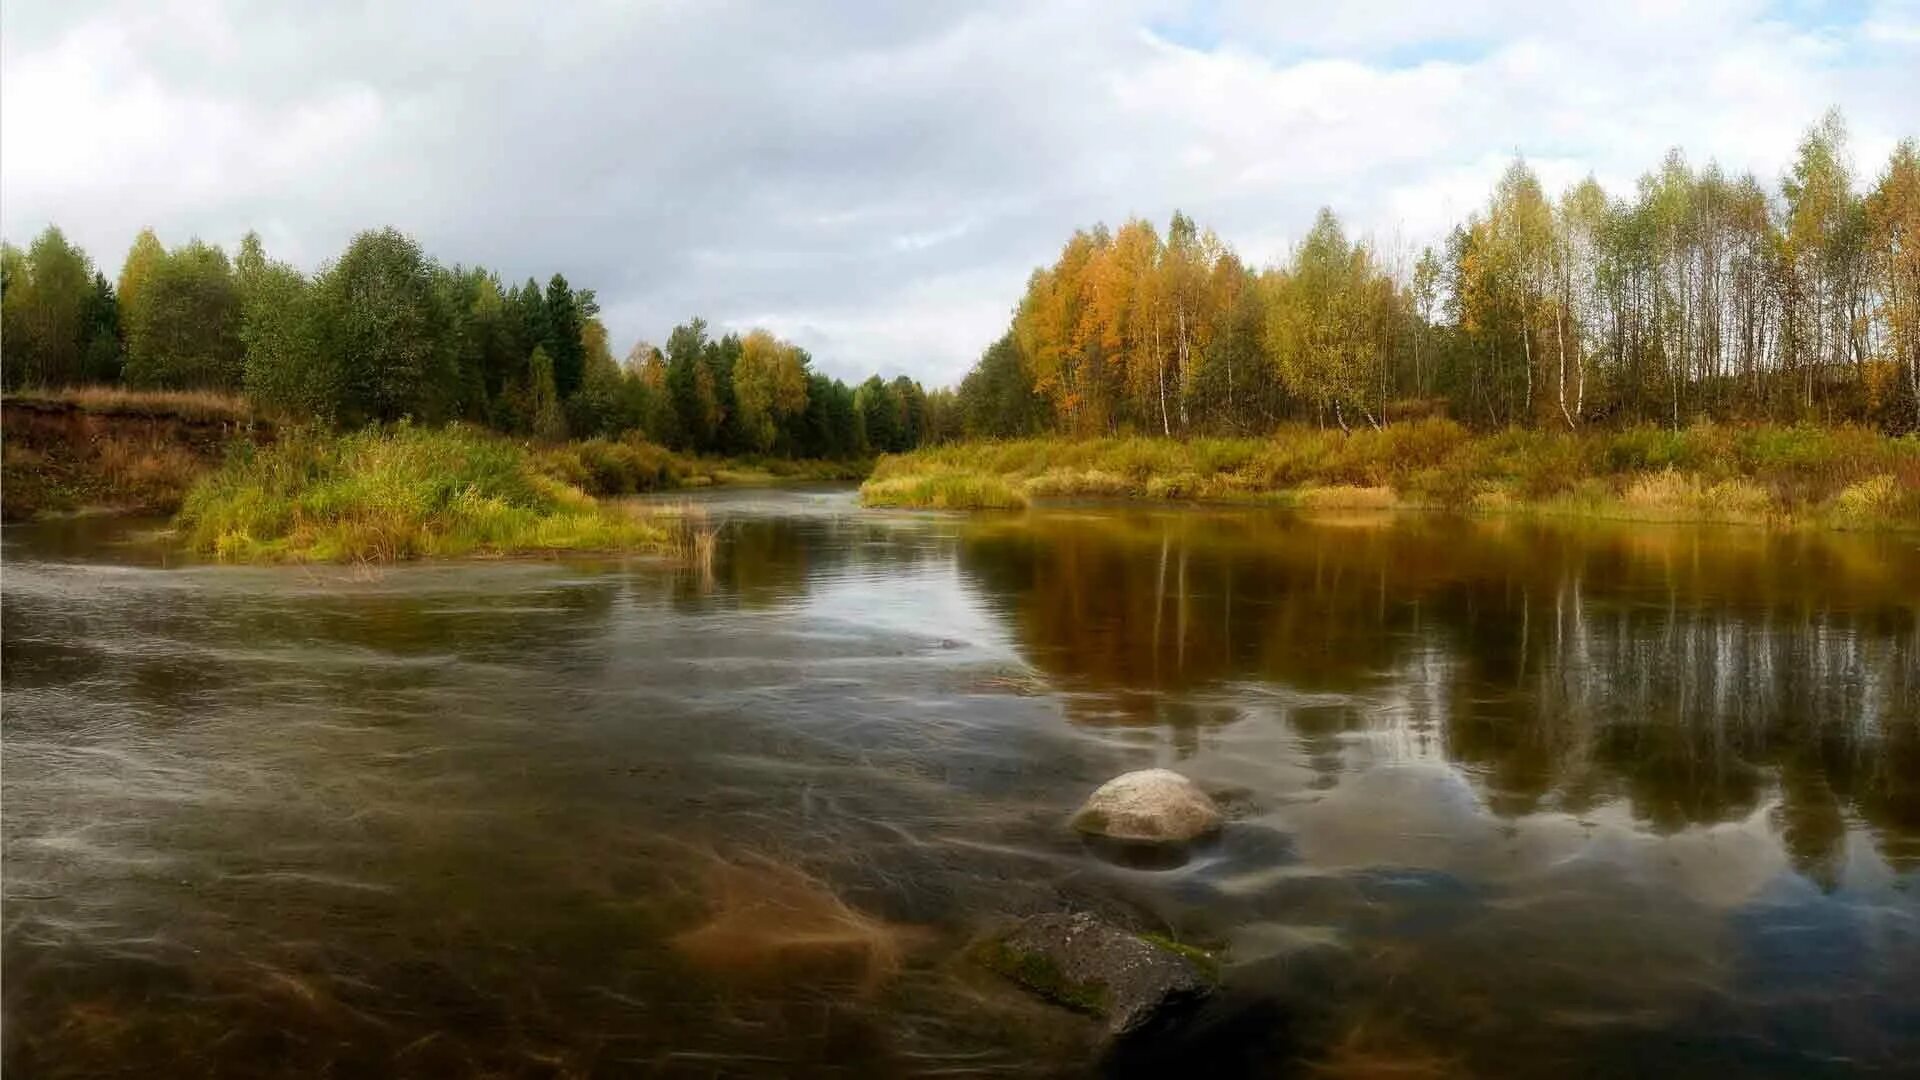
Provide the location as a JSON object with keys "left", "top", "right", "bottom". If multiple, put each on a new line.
{"left": 0, "top": 111, "right": 1920, "bottom": 459}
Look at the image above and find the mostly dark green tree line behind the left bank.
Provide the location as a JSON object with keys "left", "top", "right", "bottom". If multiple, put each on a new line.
{"left": 0, "top": 227, "right": 958, "bottom": 457}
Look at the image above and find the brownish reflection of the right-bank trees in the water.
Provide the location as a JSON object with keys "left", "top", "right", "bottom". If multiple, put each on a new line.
{"left": 960, "top": 511, "right": 1920, "bottom": 868}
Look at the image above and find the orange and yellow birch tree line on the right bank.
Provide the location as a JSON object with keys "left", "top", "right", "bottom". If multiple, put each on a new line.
{"left": 956, "top": 113, "right": 1920, "bottom": 436}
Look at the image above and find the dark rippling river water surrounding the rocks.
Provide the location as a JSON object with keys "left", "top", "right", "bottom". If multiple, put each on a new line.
{"left": 0, "top": 492, "right": 1920, "bottom": 1078}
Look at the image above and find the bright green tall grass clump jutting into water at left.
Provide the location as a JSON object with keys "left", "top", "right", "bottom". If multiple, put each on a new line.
{"left": 179, "top": 423, "right": 672, "bottom": 561}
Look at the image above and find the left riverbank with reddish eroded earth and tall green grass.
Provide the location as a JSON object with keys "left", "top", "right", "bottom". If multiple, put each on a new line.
{"left": 0, "top": 388, "right": 872, "bottom": 561}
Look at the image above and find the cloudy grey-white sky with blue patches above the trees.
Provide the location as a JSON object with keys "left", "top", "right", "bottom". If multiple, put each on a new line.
{"left": 0, "top": 0, "right": 1920, "bottom": 386}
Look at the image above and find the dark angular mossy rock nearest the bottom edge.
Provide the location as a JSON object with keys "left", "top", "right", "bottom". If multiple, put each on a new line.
{"left": 977, "top": 913, "right": 1213, "bottom": 1038}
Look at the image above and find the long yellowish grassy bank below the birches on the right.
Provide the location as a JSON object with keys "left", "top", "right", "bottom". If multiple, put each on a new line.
{"left": 860, "top": 421, "right": 1920, "bottom": 528}
